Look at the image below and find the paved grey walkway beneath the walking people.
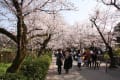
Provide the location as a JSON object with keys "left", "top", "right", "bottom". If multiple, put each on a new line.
{"left": 45, "top": 56, "right": 120, "bottom": 80}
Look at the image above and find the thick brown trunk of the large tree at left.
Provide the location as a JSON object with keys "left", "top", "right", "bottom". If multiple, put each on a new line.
{"left": 6, "top": 17, "right": 27, "bottom": 73}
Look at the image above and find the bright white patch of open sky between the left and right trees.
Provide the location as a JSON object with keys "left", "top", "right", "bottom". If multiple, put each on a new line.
{"left": 62, "top": 0, "right": 105, "bottom": 25}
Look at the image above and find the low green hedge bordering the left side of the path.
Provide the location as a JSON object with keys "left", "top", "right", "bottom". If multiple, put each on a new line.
{"left": 0, "top": 53, "right": 51, "bottom": 80}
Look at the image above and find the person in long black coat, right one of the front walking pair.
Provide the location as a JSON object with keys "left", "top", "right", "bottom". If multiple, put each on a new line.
{"left": 64, "top": 51, "right": 72, "bottom": 73}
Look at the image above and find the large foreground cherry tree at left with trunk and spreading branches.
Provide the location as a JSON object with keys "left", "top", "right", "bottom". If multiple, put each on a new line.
{"left": 0, "top": 0, "right": 73, "bottom": 73}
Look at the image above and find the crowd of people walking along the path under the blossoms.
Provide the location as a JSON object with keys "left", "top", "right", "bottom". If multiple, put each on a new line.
{"left": 54, "top": 48, "right": 102, "bottom": 74}
